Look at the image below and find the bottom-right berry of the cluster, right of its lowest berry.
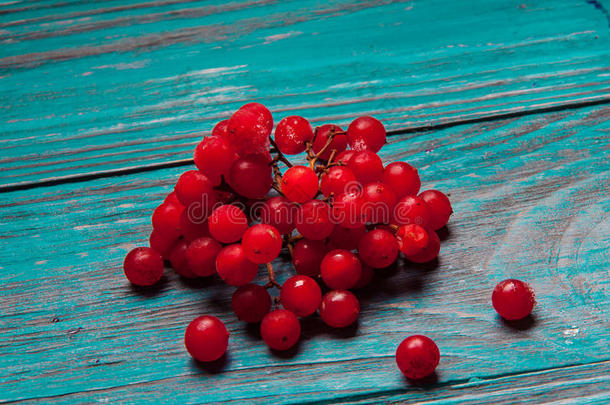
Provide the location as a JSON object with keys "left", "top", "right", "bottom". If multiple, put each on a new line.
{"left": 320, "top": 290, "right": 360, "bottom": 328}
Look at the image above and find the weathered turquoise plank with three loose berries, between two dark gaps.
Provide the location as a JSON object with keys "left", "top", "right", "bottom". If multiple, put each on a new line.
{"left": 0, "top": 107, "right": 610, "bottom": 402}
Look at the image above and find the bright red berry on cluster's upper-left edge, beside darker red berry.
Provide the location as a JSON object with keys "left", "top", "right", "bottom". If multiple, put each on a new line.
{"left": 193, "top": 136, "right": 238, "bottom": 186}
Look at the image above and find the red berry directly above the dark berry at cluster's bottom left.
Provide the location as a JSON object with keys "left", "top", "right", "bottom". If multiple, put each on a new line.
{"left": 216, "top": 243, "right": 258, "bottom": 287}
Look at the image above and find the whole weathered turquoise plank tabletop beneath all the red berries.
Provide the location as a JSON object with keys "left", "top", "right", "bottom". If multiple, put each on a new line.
{"left": 0, "top": 0, "right": 610, "bottom": 404}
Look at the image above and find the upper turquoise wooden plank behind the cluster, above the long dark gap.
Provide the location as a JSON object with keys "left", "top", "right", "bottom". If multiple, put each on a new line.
{"left": 0, "top": 0, "right": 610, "bottom": 184}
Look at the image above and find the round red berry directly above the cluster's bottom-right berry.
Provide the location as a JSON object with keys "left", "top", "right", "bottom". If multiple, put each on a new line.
{"left": 320, "top": 249, "right": 362, "bottom": 290}
